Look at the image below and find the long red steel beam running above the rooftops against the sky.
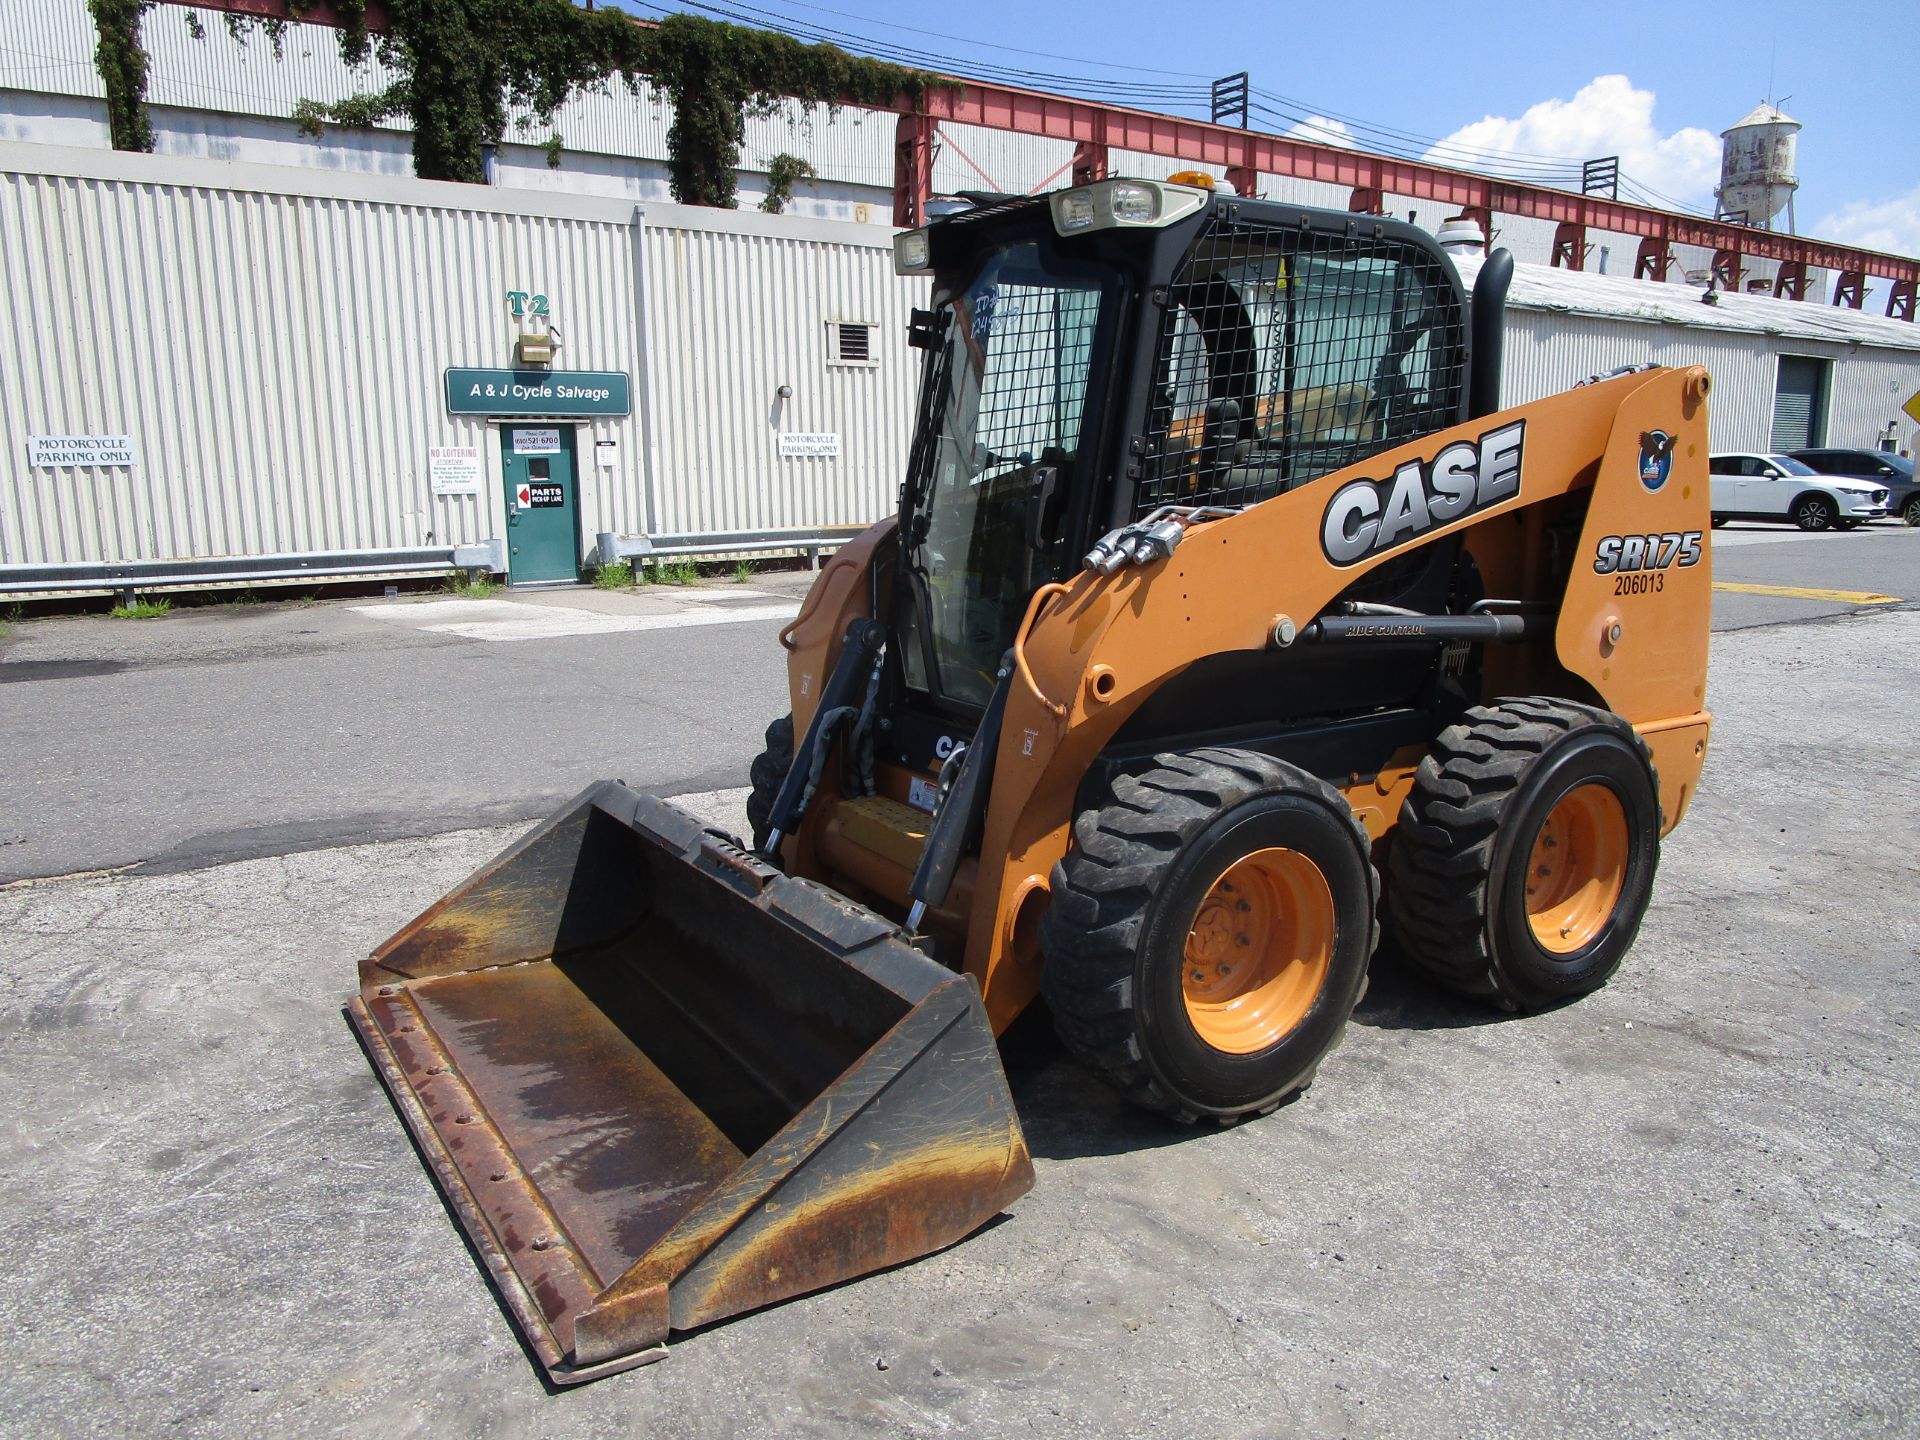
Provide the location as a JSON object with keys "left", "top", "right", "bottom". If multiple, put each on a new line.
{"left": 153, "top": 0, "right": 1920, "bottom": 313}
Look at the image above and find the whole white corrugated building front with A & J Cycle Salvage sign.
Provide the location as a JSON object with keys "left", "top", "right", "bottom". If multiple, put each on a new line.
{"left": 0, "top": 144, "right": 920, "bottom": 595}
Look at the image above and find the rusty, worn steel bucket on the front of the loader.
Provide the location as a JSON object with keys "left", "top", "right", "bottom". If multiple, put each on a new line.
{"left": 348, "top": 781, "right": 1033, "bottom": 1384}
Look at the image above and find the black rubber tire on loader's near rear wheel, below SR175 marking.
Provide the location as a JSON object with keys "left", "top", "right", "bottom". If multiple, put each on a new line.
{"left": 1386, "top": 697, "right": 1661, "bottom": 1010}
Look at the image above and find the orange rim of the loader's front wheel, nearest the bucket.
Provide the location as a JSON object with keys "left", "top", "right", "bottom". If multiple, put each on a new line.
{"left": 1181, "top": 849, "right": 1334, "bottom": 1054}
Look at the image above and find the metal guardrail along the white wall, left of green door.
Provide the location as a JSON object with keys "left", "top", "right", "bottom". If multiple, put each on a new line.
{"left": 0, "top": 540, "right": 507, "bottom": 599}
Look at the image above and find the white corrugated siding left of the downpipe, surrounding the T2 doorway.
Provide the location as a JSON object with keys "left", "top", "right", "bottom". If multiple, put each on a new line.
{"left": 0, "top": 148, "right": 641, "bottom": 564}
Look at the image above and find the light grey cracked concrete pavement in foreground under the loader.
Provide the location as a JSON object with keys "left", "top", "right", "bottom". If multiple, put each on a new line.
{"left": 0, "top": 609, "right": 1920, "bottom": 1440}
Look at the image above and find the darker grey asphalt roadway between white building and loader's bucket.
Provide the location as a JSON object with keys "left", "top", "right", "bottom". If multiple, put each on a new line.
{"left": 0, "top": 574, "right": 808, "bottom": 883}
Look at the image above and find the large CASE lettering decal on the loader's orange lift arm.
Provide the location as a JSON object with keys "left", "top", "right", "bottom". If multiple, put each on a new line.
{"left": 1321, "top": 420, "right": 1526, "bottom": 564}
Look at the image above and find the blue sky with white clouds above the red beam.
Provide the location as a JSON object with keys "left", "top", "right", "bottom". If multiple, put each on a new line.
{"left": 630, "top": 0, "right": 1920, "bottom": 253}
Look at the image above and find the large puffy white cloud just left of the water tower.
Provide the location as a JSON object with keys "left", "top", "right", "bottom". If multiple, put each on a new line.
{"left": 1427, "top": 75, "right": 1720, "bottom": 205}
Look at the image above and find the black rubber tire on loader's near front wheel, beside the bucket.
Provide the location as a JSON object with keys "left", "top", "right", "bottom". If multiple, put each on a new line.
{"left": 1041, "top": 749, "right": 1380, "bottom": 1123}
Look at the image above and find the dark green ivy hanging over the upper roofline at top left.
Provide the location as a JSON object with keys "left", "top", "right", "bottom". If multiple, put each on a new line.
{"left": 147, "top": 0, "right": 958, "bottom": 209}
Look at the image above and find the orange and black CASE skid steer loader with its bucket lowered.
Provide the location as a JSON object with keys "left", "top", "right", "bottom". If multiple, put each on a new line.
{"left": 349, "top": 180, "right": 1709, "bottom": 1382}
